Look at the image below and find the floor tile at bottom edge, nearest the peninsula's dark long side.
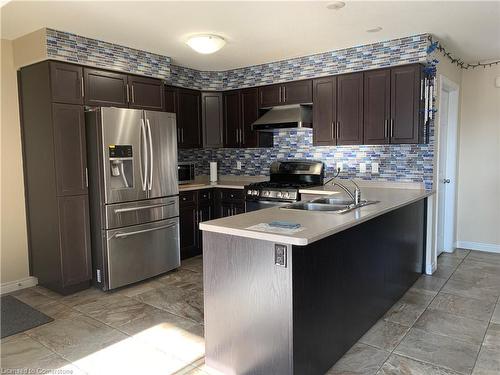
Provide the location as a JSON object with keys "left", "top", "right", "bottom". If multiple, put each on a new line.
{"left": 327, "top": 343, "right": 389, "bottom": 375}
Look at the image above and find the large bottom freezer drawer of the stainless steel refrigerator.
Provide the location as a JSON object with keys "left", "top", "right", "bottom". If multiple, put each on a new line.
{"left": 106, "top": 218, "right": 180, "bottom": 289}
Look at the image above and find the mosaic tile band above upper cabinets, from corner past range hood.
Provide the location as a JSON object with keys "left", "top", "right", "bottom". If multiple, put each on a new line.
{"left": 171, "top": 34, "right": 428, "bottom": 90}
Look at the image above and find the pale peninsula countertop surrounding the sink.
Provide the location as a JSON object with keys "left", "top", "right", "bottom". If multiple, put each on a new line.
{"left": 200, "top": 187, "right": 434, "bottom": 246}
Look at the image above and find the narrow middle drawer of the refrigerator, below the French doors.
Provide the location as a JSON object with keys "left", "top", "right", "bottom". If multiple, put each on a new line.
{"left": 103, "top": 196, "right": 179, "bottom": 229}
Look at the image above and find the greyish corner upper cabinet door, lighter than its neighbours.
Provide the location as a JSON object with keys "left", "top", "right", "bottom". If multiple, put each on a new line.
{"left": 201, "top": 92, "right": 224, "bottom": 147}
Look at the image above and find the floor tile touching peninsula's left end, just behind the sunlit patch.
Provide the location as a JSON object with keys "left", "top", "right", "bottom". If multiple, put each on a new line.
{"left": 134, "top": 286, "right": 203, "bottom": 323}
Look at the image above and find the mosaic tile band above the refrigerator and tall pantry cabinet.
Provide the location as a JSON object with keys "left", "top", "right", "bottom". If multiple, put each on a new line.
{"left": 46, "top": 29, "right": 170, "bottom": 80}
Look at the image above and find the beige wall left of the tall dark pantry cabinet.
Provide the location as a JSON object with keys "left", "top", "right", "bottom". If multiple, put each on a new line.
{"left": 0, "top": 29, "right": 46, "bottom": 292}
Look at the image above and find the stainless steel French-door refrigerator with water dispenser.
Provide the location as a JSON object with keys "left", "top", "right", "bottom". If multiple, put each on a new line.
{"left": 85, "top": 108, "right": 180, "bottom": 290}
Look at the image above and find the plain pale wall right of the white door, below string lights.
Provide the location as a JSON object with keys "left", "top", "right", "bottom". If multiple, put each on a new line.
{"left": 457, "top": 65, "right": 500, "bottom": 252}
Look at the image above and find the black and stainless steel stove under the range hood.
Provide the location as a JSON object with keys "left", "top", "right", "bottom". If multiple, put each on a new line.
{"left": 245, "top": 160, "right": 325, "bottom": 212}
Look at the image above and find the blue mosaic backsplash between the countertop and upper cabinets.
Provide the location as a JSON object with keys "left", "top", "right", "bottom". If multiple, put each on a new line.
{"left": 179, "top": 129, "right": 434, "bottom": 189}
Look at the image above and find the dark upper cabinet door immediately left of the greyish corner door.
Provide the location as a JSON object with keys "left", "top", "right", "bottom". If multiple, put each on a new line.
{"left": 177, "top": 89, "right": 202, "bottom": 148}
